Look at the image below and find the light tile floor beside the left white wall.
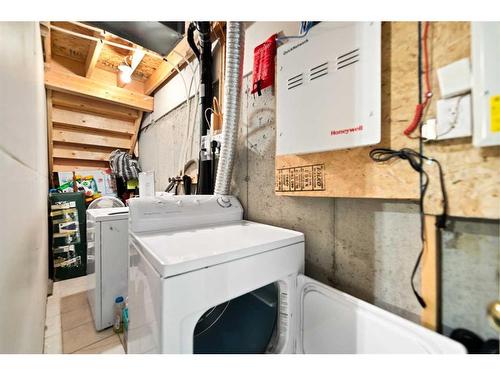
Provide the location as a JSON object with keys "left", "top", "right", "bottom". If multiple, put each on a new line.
{"left": 44, "top": 276, "right": 125, "bottom": 354}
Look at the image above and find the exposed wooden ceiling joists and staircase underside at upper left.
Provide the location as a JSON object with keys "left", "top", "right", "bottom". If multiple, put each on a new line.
{"left": 40, "top": 22, "right": 224, "bottom": 178}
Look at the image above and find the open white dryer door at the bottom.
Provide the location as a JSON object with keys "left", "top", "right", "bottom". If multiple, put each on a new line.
{"left": 296, "top": 275, "right": 465, "bottom": 354}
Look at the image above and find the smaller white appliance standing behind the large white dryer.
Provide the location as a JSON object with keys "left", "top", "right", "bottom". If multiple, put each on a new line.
{"left": 87, "top": 207, "right": 128, "bottom": 331}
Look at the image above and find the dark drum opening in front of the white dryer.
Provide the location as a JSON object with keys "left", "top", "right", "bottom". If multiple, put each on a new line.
{"left": 193, "top": 284, "right": 278, "bottom": 354}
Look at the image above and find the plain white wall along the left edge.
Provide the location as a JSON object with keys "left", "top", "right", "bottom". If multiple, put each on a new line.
{"left": 0, "top": 22, "right": 48, "bottom": 353}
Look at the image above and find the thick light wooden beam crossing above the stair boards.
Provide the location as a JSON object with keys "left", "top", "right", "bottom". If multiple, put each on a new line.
{"left": 45, "top": 68, "right": 153, "bottom": 112}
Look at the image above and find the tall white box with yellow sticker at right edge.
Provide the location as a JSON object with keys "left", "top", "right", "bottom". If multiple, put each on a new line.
{"left": 471, "top": 22, "right": 500, "bottom": 147}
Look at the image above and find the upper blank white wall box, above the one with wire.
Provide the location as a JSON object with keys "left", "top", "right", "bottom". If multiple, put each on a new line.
{"left": 437, "top": 58, "right": 471, "bottom": 99}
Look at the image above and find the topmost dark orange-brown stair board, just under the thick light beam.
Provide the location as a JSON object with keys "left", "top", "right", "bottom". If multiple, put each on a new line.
{"left": 52, "top": 91, "right": 139, "bottom": 121}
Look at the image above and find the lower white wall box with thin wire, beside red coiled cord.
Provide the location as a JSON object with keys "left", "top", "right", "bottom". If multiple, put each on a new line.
{"left": 434, "top": 94, "right": 472, "bottom": 140}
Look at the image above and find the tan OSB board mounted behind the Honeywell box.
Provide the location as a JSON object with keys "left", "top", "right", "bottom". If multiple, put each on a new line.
{"left": 276, "top": 22, "right": 500, "bottom": 219}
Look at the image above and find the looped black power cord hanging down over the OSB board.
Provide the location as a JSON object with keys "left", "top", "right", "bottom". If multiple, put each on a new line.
{"left": 370, "top": 148, "right": 448, "bottom": 308}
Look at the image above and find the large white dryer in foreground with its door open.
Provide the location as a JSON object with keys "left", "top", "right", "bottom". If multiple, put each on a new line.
{"left": 128, "top": 196, "right": 465, "bottom": 353}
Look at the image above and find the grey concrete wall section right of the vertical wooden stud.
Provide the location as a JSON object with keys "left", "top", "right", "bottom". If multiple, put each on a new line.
{"left": 442, "top": 219, "right": 500, "bottom": 339}
